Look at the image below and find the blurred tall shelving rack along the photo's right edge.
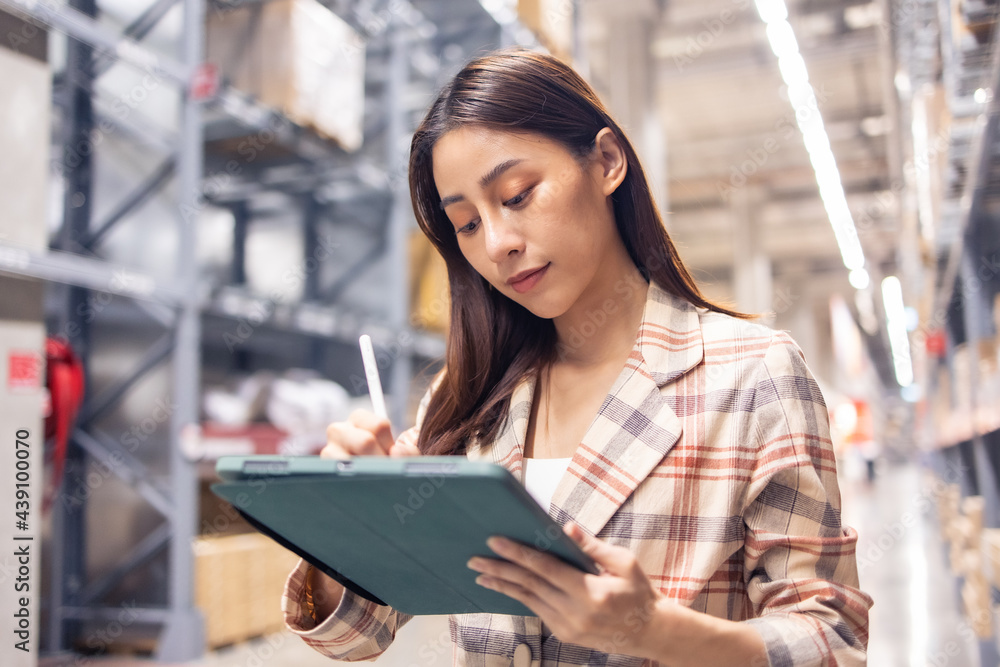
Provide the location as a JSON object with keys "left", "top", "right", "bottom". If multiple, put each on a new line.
{"left": 894, "top": 0, "right": 1000, "bottom": 665}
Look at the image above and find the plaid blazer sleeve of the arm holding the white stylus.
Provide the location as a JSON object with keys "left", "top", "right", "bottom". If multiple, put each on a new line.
{"left": 281, "top": 374, "right": 442, "bottom": 661}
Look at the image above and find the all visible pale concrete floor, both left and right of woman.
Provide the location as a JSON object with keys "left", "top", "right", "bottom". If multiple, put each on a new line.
{"left": 74, "top": 464, "right": 988, "bottom": 667}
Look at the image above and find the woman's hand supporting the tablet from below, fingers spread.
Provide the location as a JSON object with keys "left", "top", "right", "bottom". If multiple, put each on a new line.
{"left": 469, "top": 523, "right": 661, "bottom": 657}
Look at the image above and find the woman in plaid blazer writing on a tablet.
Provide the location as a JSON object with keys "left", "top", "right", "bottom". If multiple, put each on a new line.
{"left": 284, "top": 50, "right": 871, "bottom": 666}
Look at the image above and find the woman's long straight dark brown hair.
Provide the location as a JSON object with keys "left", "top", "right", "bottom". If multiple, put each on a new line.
{"left": 410, "top": 48, "right": 752, "bottom": 454}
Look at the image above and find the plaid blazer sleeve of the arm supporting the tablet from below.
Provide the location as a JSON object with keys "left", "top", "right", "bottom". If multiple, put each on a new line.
{"left": 743, "top": 332, "right": 872, "bottom": 667}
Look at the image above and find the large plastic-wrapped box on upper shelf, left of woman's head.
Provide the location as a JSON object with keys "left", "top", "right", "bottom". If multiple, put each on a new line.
{"left": 206, "top": 0, "right": 365, "bottom": 151}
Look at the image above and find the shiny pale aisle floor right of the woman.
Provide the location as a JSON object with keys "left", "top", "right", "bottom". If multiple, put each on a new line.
{"left": 841, "top": 463, "right": 979, "bottom": 667}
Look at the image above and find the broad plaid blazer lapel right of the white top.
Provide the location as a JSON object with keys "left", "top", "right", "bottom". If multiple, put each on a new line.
{"left": 548, "top": 283, "right": 703, "bottom": 535}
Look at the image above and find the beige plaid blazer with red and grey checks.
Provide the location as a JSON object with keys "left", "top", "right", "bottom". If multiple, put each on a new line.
{"left": 283, "top": 283, "right": 872, "bottom": 667}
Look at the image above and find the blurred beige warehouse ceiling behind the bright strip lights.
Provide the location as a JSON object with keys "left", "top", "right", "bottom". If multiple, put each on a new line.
{"left": 584, "top": 0, "right": 899, "bottom": 300}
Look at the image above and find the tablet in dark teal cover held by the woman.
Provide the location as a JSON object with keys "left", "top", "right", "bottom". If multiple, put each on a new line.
{"left": 212, "top": 456, "right": 598, "bottom": 616}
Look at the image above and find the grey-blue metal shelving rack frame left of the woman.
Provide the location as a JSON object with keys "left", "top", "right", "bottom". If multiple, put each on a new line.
{"left": 0, "top": 0, "right": 552, "bottom": 662}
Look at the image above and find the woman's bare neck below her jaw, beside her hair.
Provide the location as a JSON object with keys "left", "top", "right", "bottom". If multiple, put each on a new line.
{"left": 554, "top": 261, "right": 649, "bottom": 367}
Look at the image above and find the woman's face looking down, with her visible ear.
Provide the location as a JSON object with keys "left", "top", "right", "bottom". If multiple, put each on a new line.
{"left": 432, "top": 126, "right": 627, "bottom": 318}
